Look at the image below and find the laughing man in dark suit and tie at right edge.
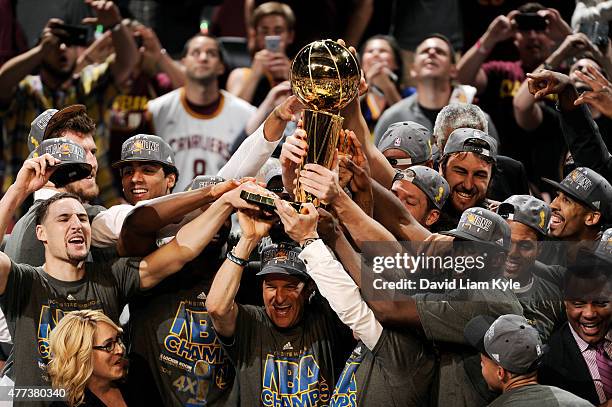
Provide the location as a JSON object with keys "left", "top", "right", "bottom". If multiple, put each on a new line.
{"left": 540, "top": 229, "right": 612, "bottom": 406}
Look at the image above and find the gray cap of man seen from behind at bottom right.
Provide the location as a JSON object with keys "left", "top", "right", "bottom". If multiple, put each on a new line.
{"left": 463, "top": 314, "right": 545, "bottom": 374}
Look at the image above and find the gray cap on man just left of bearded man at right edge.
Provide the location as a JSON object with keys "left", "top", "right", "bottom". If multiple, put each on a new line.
{"left": 497, "top": 195, "right": 551, "bottom": 236}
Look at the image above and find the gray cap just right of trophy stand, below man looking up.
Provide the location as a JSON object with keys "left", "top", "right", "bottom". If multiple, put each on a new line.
{"left": 378, "top": 122, "right": 433, "bottom": 170}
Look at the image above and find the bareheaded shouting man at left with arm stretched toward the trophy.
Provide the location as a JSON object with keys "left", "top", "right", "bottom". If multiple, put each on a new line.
{"left": 0, "top": 154, "right": 254, "bottom": 402}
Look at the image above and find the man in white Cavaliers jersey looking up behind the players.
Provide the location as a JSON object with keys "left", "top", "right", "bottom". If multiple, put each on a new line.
{"left": 148, "top": 34, "right": 256, "bottom": 190}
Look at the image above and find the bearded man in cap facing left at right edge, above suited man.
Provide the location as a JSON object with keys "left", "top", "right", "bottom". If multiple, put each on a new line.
{"left": 540, "top": 167, "right": 612, "bottom": 265}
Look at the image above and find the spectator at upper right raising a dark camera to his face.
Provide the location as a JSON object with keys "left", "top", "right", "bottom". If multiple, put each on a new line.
{"left": 457, "top": 3, "right": 571, "bottom": 167}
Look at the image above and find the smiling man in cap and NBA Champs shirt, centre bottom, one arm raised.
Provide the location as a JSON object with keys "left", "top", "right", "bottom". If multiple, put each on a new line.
{"left": 206, "top": 212, "right": 351, "bottom": 407}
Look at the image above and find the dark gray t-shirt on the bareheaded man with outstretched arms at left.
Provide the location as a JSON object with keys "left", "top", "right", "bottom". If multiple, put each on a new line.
{"left": 0, "top": 258, "right": 140, "bottom": 386}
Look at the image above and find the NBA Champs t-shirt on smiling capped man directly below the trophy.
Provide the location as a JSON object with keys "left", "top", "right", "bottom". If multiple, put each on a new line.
{"left": 222, "top": 299, "right": 353, "bottom": 407}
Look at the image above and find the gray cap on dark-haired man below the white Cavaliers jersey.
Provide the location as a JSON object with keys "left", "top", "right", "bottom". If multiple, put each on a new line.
{"left": 113, "top": 134, "right": 176, "bottom": 170}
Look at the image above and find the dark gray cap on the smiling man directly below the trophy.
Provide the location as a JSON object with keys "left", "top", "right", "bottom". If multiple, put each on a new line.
{"left": 257, "top": 243, "right": 310, "bottom": 280}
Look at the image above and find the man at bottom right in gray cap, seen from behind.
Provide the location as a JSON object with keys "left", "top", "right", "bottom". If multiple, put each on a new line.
{"left": 464, "top": 315, "right": 592, "bottom": 407}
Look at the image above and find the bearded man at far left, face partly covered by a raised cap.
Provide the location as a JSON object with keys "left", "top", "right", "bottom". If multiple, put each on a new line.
{"left": 4, "top": 105, "right": 104, "bottom": 267}
